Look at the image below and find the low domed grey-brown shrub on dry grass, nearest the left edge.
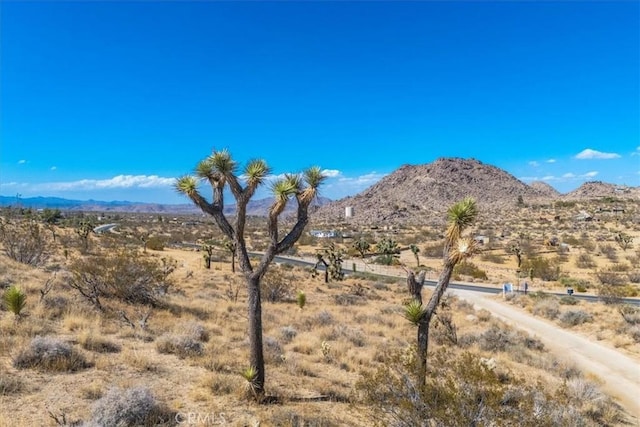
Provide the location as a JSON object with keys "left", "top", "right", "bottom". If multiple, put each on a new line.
{"left": 13, "top": 336, "right": 91, "bottom": 372}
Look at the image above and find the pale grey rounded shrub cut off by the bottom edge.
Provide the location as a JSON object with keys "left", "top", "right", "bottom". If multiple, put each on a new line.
{"left": 87, "top": 387, "right": 176, "bottom": 427}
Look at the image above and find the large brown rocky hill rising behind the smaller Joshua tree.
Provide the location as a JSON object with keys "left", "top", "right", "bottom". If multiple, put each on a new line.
{"left": 314, "top": 158, "right": 558, "bottom": 225}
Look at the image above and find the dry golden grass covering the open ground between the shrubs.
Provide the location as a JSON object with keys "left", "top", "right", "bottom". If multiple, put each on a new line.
{"left": 0, "top": 207, "right": 640, "bottom": 426}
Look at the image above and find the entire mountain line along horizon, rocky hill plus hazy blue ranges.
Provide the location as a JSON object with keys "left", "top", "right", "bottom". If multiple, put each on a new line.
{"left": 0, "top": 158, "right": 640, "bottom": 225}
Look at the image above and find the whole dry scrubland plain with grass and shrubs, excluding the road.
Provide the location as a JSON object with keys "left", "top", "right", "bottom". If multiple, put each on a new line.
{"left": 0, "top": 201, "right": 640, "bottom": 426}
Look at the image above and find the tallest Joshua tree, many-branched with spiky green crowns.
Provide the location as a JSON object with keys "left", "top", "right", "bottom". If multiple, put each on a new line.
{"left": 175, "top": 150, "right": 325, "bottom": 400}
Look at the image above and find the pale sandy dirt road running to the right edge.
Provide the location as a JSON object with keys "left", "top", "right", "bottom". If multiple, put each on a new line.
{"left": 449, "top": 290, "right": 640, "bottom": 422}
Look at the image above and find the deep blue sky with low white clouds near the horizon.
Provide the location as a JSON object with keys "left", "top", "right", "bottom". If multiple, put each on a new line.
{"left": 0, "top": 1, "right": 640, "bottom": 203}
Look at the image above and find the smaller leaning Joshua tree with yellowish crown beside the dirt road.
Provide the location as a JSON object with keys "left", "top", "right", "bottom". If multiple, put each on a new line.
{"left": 405, "top": 198, "right": 478, "bottom": 389}
